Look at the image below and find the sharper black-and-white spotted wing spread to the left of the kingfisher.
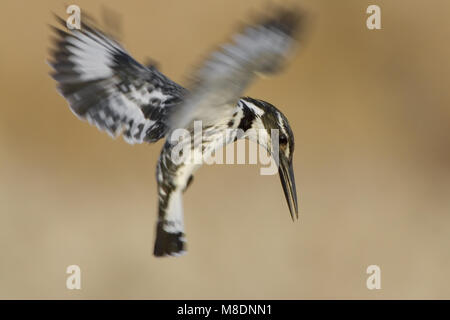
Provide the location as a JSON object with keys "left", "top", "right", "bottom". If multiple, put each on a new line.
{"left": 49, "top": 19, "right": 186, "bottom": 143}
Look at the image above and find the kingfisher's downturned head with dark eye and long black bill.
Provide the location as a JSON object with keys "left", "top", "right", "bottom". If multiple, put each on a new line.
{"left": 241, "top": 97, "right": 298, "bottom": 220}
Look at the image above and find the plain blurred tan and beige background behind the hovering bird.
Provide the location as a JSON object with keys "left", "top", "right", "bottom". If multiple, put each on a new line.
{"left": 0, "top": 0, "right": 450, "bottom": 299}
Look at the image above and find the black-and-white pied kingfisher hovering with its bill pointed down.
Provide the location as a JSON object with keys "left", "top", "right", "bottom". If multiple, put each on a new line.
{"left": 49, "top": 8, "right": 302, "bottom": 257}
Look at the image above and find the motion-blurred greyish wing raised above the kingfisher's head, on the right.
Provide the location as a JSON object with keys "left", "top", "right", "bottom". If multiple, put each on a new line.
{"left": 170, "top": 9, "right": 300, "bottom": 129}
